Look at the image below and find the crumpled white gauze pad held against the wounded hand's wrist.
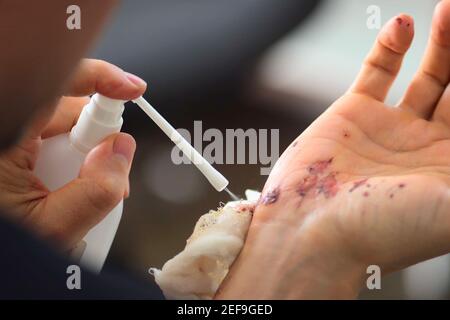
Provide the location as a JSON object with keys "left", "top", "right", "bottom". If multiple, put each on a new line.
{"left": 150, "top": 190, "right": 260, "bottom": 299}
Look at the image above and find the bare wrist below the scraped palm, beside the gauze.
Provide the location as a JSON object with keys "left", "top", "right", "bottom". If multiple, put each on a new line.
{"left": 215, "top": 219, "right": 365, "bottom": 299}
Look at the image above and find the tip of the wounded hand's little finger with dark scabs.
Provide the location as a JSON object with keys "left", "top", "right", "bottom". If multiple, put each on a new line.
{"left": 379, "top": 14, "right": 414, "bottom": 54}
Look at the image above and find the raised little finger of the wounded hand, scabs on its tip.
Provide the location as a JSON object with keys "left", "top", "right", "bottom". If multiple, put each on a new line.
{"left": 350, "top": 14, "right": 414, "bottom": 101}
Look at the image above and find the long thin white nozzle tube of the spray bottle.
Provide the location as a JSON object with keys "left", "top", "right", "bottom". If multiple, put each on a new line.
{"left": 133, "top": 97, "right": 228, "bottom": 192}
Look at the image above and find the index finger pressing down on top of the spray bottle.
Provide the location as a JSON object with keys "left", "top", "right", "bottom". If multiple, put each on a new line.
{"left": 65, "top": 59, "right": 147, "bottom": 100}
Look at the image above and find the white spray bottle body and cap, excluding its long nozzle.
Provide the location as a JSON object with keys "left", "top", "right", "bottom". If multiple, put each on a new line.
{"left": 35, "top": 94, "right": 125, "bottom": 272}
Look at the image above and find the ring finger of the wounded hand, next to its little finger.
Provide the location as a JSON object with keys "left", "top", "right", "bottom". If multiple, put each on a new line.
{"left": 400, "top": 0, "right": 450, "bottom": 119}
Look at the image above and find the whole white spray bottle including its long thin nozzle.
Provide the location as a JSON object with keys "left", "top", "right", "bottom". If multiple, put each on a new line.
{"left": 35, "top": 93, "right": 230, "bottom": 272}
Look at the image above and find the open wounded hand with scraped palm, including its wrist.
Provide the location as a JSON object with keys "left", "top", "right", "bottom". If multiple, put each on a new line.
{"left": 216, "top": 0, "right": 450, "bottom": 299}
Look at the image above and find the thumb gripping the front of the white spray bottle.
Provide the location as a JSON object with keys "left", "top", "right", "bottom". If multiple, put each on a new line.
{"left": 39, "top": 133, "right": 136, "bottom": 247}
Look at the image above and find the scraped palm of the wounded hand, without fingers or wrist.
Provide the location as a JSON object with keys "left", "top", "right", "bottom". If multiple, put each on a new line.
{"left": 262, "top": 94, "right": 450, "bottom": 269}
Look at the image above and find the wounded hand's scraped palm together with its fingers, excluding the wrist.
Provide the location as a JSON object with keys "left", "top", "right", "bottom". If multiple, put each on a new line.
{"left": 255, "top": 10, "right": 450, "bottom": 272}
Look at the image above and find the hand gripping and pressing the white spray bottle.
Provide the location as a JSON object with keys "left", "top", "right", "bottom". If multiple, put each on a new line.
{"left": 0, "top": 59, "right": 146, "bottom": 251}
